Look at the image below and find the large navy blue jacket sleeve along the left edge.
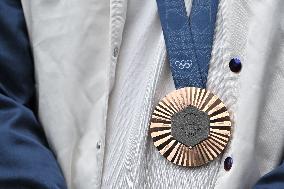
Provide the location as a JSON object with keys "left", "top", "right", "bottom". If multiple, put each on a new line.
{"left": 0, "top": 0, "right": 67, "bottom": 189}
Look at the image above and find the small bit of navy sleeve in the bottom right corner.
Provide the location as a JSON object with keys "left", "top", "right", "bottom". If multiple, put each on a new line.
{"left": 254, "top": 162, "right": 284, "bottom": 189}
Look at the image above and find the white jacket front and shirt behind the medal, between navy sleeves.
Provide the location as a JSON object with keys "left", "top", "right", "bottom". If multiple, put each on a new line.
{"left": 22, "top": 0, "right": 284, "bottom": 189}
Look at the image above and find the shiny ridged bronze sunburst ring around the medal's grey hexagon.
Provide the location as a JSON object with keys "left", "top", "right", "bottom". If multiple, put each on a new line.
{"left": 150, "top": 87, "right": 231, "bottom": 167}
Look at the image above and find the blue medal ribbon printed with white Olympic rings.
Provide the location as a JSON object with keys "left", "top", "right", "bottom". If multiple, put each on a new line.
{"left": 157, "top": 0, "right": 218, "bottom": 89}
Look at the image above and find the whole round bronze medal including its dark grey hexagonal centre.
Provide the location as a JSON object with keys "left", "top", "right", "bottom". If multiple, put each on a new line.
{"left": 150, "top": 87, "right": 232, "bottom": 167}
